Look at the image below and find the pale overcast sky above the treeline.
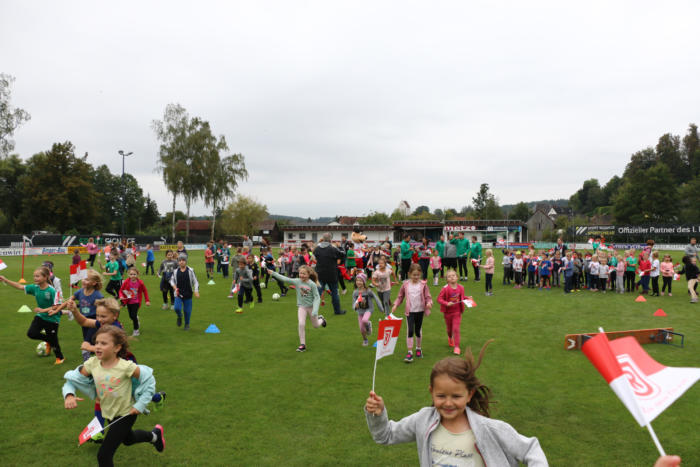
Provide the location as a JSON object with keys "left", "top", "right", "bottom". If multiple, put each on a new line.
{"left": 0, "top": 0, "right": 700, "bottom": 217}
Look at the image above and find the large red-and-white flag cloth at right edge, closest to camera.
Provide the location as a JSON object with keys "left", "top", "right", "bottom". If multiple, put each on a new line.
{"left": 581, "top": 333, "right": 700, "bottom": 426}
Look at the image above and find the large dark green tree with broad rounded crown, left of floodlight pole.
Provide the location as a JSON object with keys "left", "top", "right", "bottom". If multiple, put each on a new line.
{"left": 18, "top": 142, "right": 97, "bottom": 232}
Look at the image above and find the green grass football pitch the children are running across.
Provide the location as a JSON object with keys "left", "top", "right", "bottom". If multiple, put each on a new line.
{"left": 0, "top": 252, "right": 700, "bottom": 466}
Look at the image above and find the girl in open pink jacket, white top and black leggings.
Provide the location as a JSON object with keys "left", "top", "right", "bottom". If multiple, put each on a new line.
{"left": 391, "top": 263, "right": 433, "bottom": 363}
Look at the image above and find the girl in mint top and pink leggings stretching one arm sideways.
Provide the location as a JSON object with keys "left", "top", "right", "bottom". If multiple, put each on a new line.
{"left": 268, "top": 265, "right": 326, "bottom": 352}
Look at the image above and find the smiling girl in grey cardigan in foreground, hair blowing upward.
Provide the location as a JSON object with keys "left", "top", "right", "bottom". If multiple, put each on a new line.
{"left": 365, "top": 341, "right": 548, "bottom": 466}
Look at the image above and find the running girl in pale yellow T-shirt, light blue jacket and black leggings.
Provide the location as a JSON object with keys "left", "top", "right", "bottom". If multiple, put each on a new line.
{"left": 63, "top": 326, "right": 165, "bottom": 466}
